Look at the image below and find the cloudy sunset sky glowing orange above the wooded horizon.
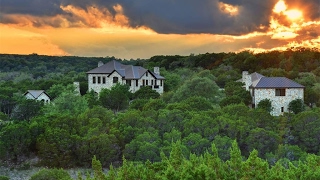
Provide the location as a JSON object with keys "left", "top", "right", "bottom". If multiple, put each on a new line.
{"left": 0, "top": 0, "right": 320, "bottom": 59}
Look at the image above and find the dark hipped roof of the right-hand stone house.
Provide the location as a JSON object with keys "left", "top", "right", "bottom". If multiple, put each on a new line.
{"left": 254, "top": 77, "right": 304, "bottom": 88}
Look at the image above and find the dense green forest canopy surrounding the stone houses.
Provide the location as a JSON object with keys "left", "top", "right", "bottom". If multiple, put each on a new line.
{"left": 0, "top": 48, "right": 320, "bottom": 179}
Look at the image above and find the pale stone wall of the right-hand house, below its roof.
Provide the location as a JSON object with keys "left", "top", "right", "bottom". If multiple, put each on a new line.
{"left": 253, "top": 88, "right": 304, "bottom": 116}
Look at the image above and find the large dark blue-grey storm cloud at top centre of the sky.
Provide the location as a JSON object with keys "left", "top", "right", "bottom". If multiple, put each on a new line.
{"left": 99, "top": 0, "right": 276, "bottom": 34}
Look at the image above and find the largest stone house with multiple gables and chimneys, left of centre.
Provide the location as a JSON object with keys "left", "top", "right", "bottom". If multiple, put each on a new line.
{"left": 87, "top": 60, "right": 165, "bottom": 94}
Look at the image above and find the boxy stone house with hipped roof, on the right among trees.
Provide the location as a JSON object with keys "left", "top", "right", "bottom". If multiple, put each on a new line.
{"left": 239, "top": 71, "right": 304, "bottom": 116}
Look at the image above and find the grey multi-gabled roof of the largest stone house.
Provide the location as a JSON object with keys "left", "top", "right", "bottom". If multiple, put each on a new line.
{"left": 87, "top": 60, "right": 165, "bottom": 79}
